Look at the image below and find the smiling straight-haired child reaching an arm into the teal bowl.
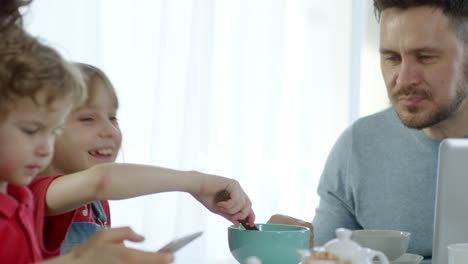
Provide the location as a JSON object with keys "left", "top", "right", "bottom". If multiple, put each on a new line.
{"left": 31, "top": 63, "right": 255, "bottom": 253}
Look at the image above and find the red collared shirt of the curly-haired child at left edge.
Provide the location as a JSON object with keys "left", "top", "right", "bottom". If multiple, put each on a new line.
{"left": 0, "top": 184, "right": 42, "bottom": 263}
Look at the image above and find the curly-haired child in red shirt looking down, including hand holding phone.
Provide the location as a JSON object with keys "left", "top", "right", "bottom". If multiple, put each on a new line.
{"left": 0, "top": 23, "right": 173, "bottom": 264}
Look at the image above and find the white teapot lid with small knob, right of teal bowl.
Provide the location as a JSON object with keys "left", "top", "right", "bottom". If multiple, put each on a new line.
{"left": 323, "top": 228, "right": 361, "bottom": 258}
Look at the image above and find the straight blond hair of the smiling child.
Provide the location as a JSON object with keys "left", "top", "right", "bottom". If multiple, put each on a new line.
{"left": 74, "top": 62, "right": 119, "bottom": 108}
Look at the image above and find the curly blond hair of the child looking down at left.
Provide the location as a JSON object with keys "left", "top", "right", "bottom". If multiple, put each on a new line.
{"left": 0, "top": 27, "right": 86, "bottom": 118}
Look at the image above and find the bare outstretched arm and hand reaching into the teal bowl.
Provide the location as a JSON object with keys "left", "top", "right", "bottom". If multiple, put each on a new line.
{"left": 46, "top": 163, "right": 255, "bottom": 225}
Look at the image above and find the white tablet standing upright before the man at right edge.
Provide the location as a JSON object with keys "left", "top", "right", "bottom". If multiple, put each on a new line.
{"left": 432, "top": 139, "right": 468, "bottom": 264}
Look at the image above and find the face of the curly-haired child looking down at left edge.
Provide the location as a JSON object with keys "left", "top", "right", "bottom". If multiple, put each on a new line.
{"left": 0, "top": 93, "right": 72, "bottom": 192}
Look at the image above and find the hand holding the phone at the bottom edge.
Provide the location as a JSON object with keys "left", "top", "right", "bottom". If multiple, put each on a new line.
{"left": 66, "top": 227, "right": 174, "bottom": 264}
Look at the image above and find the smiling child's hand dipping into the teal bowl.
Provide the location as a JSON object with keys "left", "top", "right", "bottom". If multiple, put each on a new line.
{"left": 192, "top": 175, "right": 255, "bottom": 226}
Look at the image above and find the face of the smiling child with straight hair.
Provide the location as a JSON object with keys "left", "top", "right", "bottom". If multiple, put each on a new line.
{"left": 47, "top": 79, "right": 122, "bottom": 174}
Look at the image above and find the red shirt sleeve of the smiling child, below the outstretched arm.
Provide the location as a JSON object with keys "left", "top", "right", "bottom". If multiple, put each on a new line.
{"left": 28, "top": 175, "right": 77, "bottom": 258}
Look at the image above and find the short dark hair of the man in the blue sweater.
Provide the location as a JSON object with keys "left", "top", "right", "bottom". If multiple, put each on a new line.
{"left": 374, "top": 0, "right": 468, "bottom": 43}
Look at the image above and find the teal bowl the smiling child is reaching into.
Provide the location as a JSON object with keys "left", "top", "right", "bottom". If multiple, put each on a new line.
{"left": 228, "top": 224, "right": 310, "bottom": 264}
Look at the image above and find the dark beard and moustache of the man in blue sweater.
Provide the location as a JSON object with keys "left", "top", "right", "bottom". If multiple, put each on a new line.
{"left": 393, "top": 65, "right": 468, "bottom": 129}
